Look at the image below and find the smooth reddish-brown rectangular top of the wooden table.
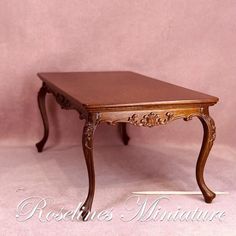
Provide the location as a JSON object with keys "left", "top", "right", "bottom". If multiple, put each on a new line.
{"left": 38, "top": 71, "right": 218, "bottom": 108}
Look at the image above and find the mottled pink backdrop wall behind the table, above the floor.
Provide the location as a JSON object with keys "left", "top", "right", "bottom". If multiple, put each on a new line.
{"left": 0, "top": 0, "right": 236, "bottom": 148}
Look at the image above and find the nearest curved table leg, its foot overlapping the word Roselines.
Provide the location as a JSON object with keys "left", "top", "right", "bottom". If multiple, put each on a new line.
{"left": 81, "top": 121, "right": 96, "bottom": 221}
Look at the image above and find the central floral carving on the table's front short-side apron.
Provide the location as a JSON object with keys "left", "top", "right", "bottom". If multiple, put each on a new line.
{"left": 128, "top": 112, "right": 174, "bottom": 127}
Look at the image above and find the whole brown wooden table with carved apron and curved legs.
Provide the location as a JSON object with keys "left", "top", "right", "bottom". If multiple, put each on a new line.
{"left": 36, "top": 71, "right": 218, "bottom": 218}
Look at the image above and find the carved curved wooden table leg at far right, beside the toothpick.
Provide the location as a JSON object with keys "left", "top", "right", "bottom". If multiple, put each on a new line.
{"left": 196, "top": 114, "right": 216, "bottom": 203}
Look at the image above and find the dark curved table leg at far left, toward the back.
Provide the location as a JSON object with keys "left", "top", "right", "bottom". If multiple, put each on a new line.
{"left": 36, "top": 84, "right": 49, "bottom": 152}
